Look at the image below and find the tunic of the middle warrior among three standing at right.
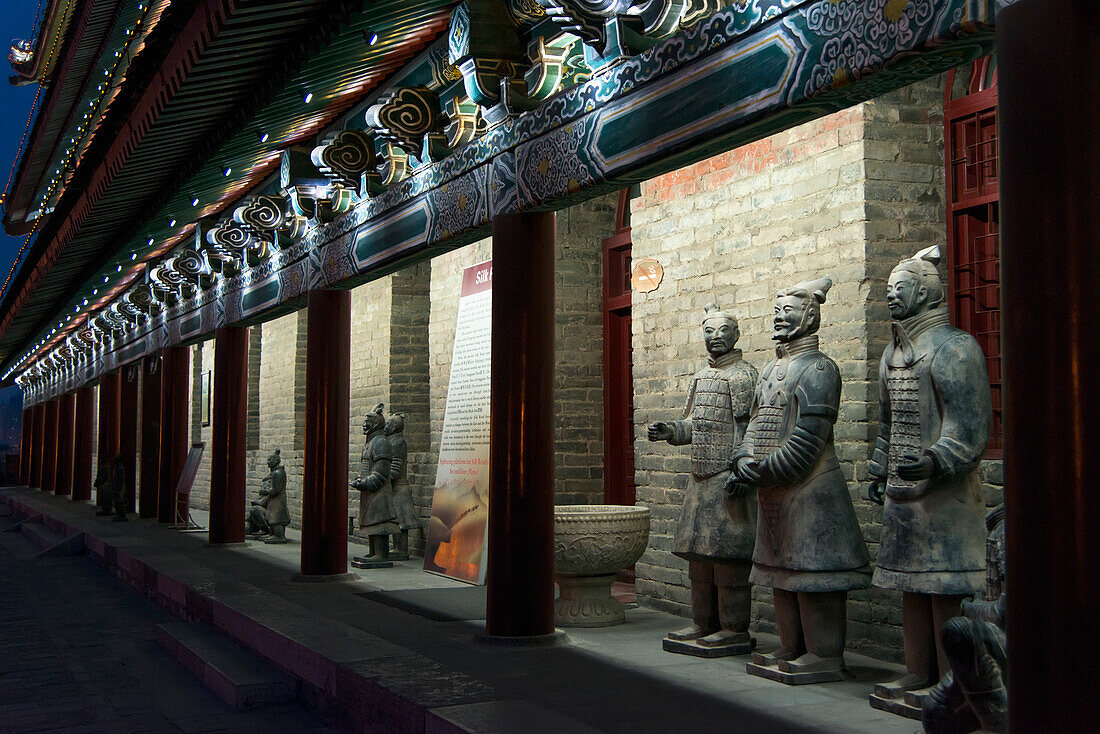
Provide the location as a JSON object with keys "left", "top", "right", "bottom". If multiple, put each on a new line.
{"left": 735, "top": 335, "right": 870, "bottom": 592}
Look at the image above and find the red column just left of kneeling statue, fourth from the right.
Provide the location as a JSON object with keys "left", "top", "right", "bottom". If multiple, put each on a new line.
{"left": 209, "top": 327, "right": 249, "bottom": 545}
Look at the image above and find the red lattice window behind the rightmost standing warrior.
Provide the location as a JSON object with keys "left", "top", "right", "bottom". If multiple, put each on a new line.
{"left": 944, "top": 58, "right": 1002, "bottom": 459}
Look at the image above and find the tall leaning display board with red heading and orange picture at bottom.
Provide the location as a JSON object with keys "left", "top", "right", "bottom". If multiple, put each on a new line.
{"left": 424, "top": 262, "right": 493, "bottom": 584}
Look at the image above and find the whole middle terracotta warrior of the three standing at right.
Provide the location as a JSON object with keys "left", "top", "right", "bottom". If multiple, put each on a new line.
{"left": 729, "top": 277, "right": 870, "bottom": 682}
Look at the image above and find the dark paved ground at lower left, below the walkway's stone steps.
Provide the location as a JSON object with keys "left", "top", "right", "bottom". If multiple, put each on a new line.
{"left": 0, "top": 505, "right": 334, "bottom": 734}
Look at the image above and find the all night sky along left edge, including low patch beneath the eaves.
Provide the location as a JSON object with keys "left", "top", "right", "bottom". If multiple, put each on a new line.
{"left": 0, "top": 0, "right": 47, "bottom": 440}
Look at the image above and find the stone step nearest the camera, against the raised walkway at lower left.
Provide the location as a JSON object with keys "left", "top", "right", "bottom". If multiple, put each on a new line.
{"left": 156, "top": 622, "right": 298, "bottom": 711}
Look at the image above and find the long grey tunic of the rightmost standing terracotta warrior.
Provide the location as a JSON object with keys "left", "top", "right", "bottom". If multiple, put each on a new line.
{"left": 869, "top": 307, "right": 992, "bottom": 594}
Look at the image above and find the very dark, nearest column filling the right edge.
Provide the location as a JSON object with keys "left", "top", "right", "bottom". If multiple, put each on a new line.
{"left": 997, "top": 0, "right": 1100, "bottom": 732}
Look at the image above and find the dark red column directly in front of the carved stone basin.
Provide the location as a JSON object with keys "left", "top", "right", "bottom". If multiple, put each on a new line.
{"left": 485, "top": 212, "right": 554, "bottom": 637}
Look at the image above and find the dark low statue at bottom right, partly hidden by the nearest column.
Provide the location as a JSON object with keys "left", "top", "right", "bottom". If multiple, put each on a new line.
{"left": 922, "top": 504, "right": 1009, "bottom": 734}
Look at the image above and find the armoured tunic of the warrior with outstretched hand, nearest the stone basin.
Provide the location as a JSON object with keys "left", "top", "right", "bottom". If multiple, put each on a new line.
{"left": 669, "top": 349, "right": 757, "bottom": 573}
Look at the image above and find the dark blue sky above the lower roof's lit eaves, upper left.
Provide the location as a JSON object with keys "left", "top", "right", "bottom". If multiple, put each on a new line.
{"left": 0, "top": 0, "right": 46, "bottom": 294}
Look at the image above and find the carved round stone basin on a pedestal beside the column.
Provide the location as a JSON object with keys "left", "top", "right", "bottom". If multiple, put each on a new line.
{"left": 553, "top": 505, "right": 649, "bottom": 627}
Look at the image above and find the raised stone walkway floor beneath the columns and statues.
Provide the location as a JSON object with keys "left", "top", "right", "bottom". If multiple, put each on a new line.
{"left": 0, "top": 490, "right": 920, "bottom": 734}
